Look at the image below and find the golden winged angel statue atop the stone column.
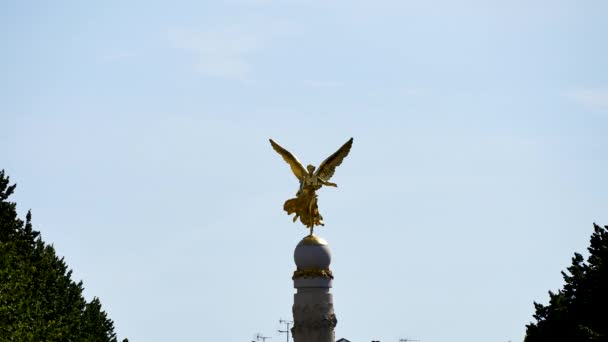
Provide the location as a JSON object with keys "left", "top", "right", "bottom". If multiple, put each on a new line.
{"left": 270, "top": 138, "right": 353, "bottom": 235}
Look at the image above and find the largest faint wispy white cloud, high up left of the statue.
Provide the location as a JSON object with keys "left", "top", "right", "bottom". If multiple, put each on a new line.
{"left": 169, "top": 28, "right": 262, "bottom": 80}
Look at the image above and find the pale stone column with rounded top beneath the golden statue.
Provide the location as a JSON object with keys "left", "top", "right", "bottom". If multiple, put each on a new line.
{"left": 291, "top": 235, "right": 338, "bottom": 342}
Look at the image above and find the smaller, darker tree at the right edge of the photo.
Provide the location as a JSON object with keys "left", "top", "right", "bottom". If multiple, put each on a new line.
{"left": 525, "top": 224, "right": 608, "bottom": 342}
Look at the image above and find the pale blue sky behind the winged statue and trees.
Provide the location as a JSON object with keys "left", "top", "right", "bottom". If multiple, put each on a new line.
{"left": 0, "top": 0, "right": 608, "bottom": 342}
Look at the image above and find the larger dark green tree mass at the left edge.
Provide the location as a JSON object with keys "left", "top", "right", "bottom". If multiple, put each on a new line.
{"left": 0, "top": 170, "right": 125, "bottom": 342}
